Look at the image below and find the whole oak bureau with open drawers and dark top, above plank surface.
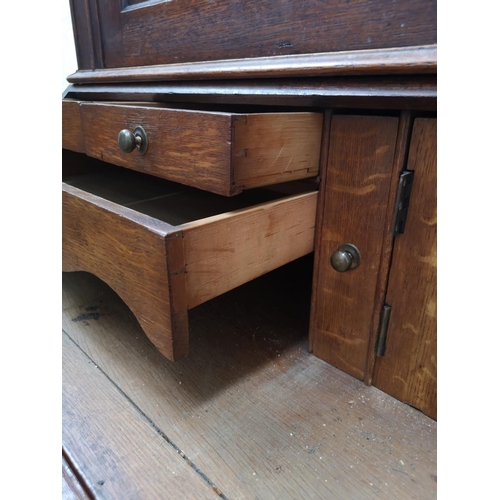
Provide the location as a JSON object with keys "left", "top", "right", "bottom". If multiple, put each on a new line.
{"left": 63, "top": 0, "right": 437, "bottom": 418}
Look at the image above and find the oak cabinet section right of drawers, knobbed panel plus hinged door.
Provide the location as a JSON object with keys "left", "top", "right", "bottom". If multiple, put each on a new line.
{"left": 310, "top": 114, "right": 437, "bottom": 418}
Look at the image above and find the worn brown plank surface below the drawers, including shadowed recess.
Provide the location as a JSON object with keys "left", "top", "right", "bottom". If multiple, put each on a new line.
{"left": 62, "top": 256, "right": 437, "bottom": 500}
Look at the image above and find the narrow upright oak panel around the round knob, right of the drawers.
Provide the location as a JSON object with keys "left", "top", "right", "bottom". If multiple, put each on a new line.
{"left": 311, "top": 115, "right": 398, "bottom": 379}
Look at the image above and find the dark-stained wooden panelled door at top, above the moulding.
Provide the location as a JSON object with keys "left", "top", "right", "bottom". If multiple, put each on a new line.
{"left": 70, "top": 0, "right": 437, "bottom": 69}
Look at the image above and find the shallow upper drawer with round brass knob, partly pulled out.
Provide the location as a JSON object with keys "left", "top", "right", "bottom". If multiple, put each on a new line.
{"left": 63, "top": 100, "right": 323, "bottom": 196}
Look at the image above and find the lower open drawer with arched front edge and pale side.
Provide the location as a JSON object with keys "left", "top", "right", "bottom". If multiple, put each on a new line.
{"left": 63, "top": 154, "right": 317, "bottom": 360}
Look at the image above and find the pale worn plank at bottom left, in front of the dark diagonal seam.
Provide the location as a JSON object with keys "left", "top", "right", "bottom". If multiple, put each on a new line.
{"left": 62, "top": 334, "right": 218, "bottom": 500}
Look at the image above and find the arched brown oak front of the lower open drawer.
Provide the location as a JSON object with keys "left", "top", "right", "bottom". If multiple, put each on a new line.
{"left": 62, "top": 183, "right": 188, "bottom": 360}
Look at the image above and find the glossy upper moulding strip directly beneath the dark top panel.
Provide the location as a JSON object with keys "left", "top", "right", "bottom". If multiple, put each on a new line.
{"left": 68, "top": 45, "right": 437, "bottom": 83}
